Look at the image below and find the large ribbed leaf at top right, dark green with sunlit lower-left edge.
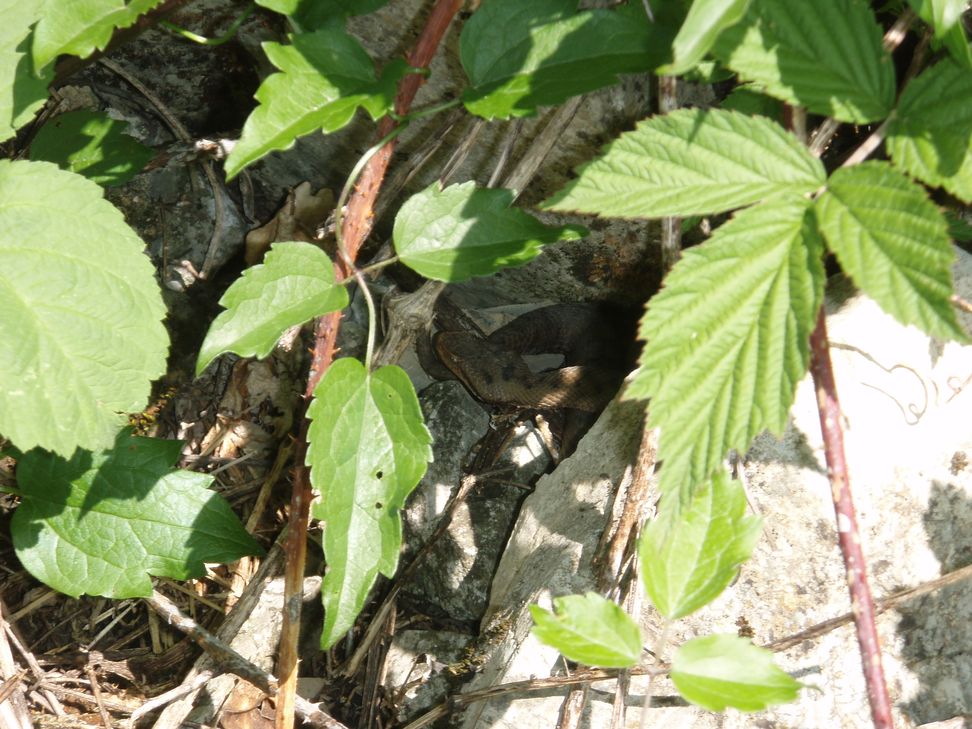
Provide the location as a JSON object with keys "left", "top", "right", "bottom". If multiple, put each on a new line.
{"left": 713, "top": 0, "right": 895, "bottom": 123}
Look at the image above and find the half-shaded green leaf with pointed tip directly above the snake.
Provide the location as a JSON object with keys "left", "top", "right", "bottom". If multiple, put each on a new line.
{"left": 393, "top": 182, "right": 587, "bottom": 282}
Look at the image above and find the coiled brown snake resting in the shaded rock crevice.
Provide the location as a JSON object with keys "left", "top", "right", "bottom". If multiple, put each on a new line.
{"left": 432, "top": 304, "right": 634, "bottom": 413}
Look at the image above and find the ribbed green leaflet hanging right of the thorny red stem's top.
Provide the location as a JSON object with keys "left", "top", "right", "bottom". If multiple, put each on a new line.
{"left": 817, "top": 162, "right": 968, "bottom": 341}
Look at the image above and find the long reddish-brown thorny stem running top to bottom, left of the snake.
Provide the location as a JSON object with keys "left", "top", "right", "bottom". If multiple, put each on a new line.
{"left": 275, "top": 0, "right": 462, "bottom": 729}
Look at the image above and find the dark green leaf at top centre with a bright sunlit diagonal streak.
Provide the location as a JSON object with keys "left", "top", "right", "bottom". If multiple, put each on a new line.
{"left": 460, "top": 0, "right": 684, "bottom": 119}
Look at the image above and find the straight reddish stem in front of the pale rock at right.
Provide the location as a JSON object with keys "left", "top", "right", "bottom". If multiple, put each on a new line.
{"left": 810, "top": 307, "right": 893, "bottom": 729}
